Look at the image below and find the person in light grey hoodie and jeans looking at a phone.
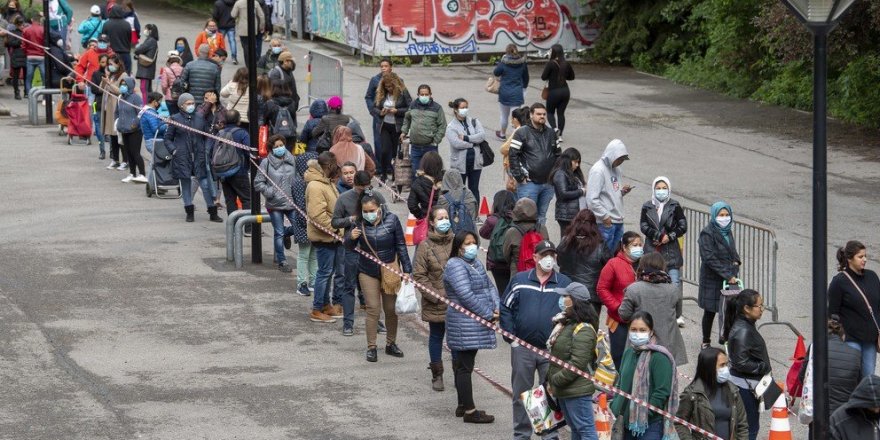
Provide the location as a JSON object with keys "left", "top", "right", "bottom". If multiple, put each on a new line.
{"left": 587, "top": 139, "right": 632, "bottom": 252}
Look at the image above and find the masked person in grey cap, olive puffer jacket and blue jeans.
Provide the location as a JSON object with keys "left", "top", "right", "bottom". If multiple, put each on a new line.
{"left": 547, "top": 283, "right": 599, "bottom": 440}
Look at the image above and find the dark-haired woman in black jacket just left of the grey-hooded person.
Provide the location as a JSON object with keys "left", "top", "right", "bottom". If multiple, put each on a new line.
{"left": 550, "top": 148, "right": 587, "bottom": 234}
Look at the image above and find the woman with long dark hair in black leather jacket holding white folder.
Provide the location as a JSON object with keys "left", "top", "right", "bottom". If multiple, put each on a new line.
{"left": 724, "top": 289, "right": 772, "bottom": 440}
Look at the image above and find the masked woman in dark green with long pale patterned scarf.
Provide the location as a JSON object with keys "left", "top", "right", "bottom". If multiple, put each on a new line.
{"left": 609, "top": 312, "right": 679, "bottom": 440}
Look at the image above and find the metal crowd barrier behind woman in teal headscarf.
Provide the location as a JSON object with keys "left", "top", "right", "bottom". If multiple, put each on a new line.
{"left": 681, "top": 207, "right": 801, "bottom": 335}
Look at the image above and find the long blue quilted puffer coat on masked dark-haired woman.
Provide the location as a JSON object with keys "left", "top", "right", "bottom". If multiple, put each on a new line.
{"left": 443, "top": 257, "right": 500, "bottom": 351}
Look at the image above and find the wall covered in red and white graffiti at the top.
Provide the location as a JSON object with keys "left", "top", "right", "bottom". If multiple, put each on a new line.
{"left": 304, "top": 0, "right": 598, "bottom": 55}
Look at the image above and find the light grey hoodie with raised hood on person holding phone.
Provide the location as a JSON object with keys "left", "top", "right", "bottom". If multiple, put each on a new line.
{"left": 587, "top": 139, "right": 629, "bottom": 223}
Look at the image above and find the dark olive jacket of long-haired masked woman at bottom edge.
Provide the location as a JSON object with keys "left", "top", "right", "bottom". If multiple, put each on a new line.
{"left": 675, "top": 379, "right": 749, "bottom": 440}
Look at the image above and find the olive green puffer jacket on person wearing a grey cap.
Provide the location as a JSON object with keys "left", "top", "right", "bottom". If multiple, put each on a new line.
{"left": 547, "top": 322, "right": 597, "bottom": 399}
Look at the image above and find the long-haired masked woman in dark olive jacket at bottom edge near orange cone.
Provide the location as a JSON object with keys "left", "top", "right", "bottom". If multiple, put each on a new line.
{"left": 675, "top": 347, "right": 749, "bottom": 440}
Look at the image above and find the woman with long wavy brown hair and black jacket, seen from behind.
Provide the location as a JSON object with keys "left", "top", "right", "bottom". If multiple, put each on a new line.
{"left": 556, "top": 209, "right": 614, "bottom": 315}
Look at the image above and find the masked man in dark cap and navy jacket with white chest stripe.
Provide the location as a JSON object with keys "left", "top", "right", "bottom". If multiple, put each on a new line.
{"left": 501, "top": 241, "right": 571, "bottom": 440}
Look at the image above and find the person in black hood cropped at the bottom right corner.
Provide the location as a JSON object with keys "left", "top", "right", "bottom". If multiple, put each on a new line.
{"left": 828, "top": 375, "right": 880, "bottom": 440}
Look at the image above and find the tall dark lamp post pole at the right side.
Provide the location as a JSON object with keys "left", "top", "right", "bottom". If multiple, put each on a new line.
{"left": 812, "top": 25, "right": 831, "bottom": 440}
